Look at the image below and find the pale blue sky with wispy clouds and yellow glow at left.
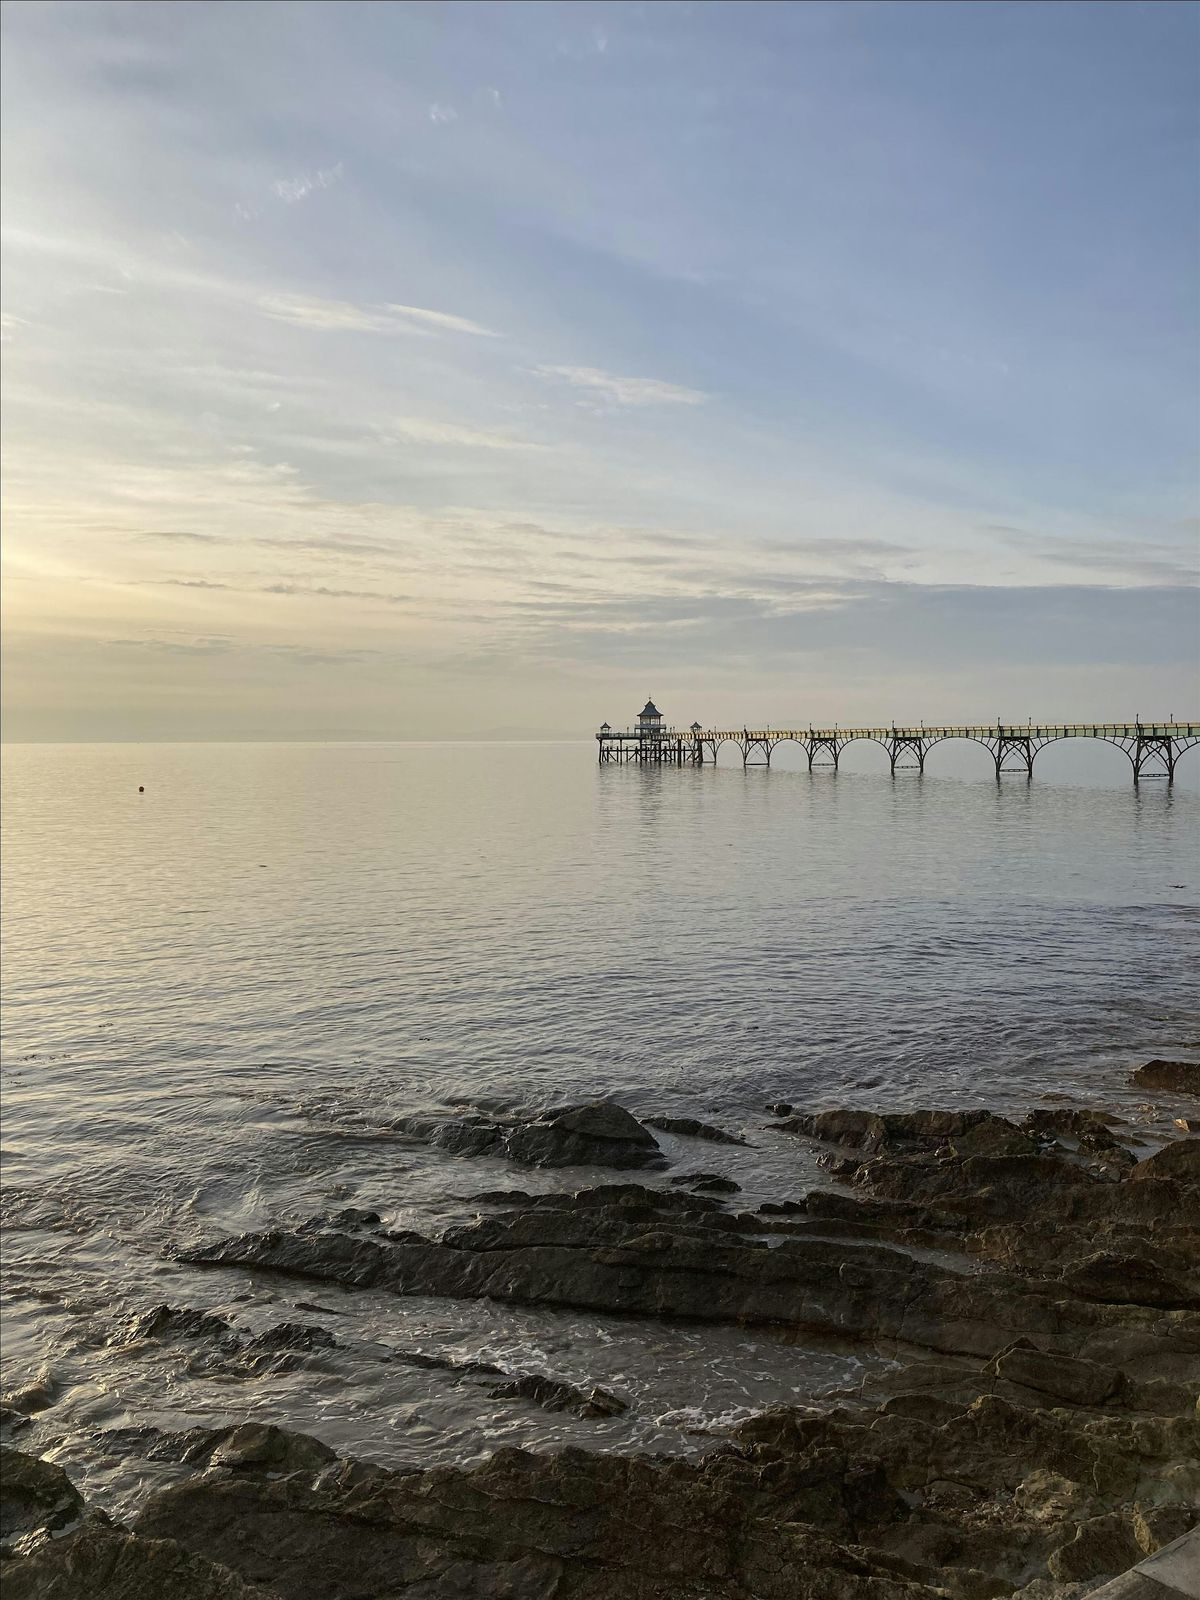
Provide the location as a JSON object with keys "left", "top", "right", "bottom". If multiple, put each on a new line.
{"left": 2, "top": 0, "right": 1200, "bottom": 739}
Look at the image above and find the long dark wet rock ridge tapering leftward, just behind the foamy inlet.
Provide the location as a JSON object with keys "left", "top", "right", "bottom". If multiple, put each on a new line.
{"left": 184, "top": 1184, "right": 1196, "bottom": 1357}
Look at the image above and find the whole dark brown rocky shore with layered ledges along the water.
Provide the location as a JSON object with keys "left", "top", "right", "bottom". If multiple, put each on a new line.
{"left": 0, "top": 1088, "right": 1200, "bottom": 1600}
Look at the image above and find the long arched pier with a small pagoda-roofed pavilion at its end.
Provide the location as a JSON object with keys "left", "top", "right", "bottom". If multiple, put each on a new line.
{"left": 595, "top": 701, "right": 1200, "bottom": 784}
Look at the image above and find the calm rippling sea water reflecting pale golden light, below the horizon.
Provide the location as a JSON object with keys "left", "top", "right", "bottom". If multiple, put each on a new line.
{"left": 3, "top": 744, "right": 1200, "bottom": 1509}
